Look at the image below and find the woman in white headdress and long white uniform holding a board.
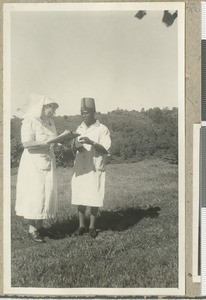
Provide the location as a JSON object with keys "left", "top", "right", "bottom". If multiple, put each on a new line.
{"left": 15, "top": 94, "right": 58, "bottom": 243}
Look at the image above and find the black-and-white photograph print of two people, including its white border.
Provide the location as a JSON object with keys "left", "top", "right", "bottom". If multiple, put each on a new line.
{"left": 3, "top": 2, "right": 185, "bottom": 296}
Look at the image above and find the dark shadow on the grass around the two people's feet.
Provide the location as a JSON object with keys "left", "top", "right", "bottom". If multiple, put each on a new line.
{"left": 45, "top": 206, "right": 161, "bottom": 239}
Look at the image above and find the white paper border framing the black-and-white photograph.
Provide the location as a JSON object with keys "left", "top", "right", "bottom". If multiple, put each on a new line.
{"left": 3, "top": 2, "right": 185, "bottom": 297}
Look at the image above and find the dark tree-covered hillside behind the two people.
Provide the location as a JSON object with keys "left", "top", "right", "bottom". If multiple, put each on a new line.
{"left": 11, "top": 108, "right": 178, "bottom": 165}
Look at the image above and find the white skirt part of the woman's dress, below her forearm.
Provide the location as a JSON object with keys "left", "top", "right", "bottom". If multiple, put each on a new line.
{"left": 15, "top": 149, "right": 58, "bottom": 220}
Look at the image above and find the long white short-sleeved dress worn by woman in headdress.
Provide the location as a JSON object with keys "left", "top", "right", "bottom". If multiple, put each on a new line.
{"left": 15, "top": 118, "right": 58, "bottom": 220}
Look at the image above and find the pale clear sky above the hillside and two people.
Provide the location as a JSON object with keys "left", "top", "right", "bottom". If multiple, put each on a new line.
{"left": 11, "top": 6, "right": 178, "bottom": 115}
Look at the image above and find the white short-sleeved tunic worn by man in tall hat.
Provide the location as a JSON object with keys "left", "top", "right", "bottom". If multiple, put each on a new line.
{"left": 72, "top": 120, "right": 111, "bottom": 207}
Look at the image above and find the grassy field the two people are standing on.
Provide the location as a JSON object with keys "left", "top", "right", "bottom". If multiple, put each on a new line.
{"left": 11, "top": 160, "right": 178, "bottom": 288}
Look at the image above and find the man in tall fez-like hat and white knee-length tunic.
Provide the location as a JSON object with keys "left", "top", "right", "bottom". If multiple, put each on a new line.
{"left": 72, "top": 98, "right": 111, "bottom": 238}
